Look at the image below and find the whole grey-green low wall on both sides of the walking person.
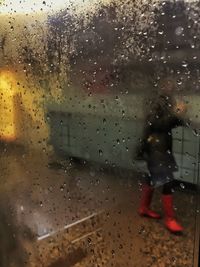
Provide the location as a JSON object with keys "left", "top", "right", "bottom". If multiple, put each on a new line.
{"left": 49, "top": 111, "right": 199, "bottom": 183}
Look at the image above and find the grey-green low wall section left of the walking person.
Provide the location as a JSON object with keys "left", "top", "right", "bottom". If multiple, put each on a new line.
{"left": 49, "top": 112, "right": 142, "bottom": 169}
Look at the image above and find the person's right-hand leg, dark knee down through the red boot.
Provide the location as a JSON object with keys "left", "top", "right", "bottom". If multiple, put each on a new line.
{"left": 162, "top": 179, "right": 183, "bottom": 233}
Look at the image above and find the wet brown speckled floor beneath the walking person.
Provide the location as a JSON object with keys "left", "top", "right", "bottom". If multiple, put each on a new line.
{"left": 0, "top": 146, "right": 196, "bottom": 267}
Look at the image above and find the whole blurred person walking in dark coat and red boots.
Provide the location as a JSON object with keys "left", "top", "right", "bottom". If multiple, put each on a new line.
{"left": 139, "top": 79, "right": 186, "bottom": 232}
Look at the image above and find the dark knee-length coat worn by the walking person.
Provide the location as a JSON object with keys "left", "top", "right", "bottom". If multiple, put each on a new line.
{"left": 138, "top": 95, "right": 183, "bottom": 174}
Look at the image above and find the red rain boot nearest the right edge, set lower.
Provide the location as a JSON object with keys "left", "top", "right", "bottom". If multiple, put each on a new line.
{"left": 162, "top": 194, "right": 183, "bottom": 233}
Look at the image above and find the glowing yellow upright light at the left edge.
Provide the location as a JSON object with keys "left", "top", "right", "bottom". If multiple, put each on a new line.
{"left": 0, "top": 71, "right": 15, "bottom": 141}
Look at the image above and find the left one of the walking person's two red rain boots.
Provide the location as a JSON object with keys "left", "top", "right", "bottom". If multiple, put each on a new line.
{"left": 139, "top": 184, "right": 161, "bottom": 219}
